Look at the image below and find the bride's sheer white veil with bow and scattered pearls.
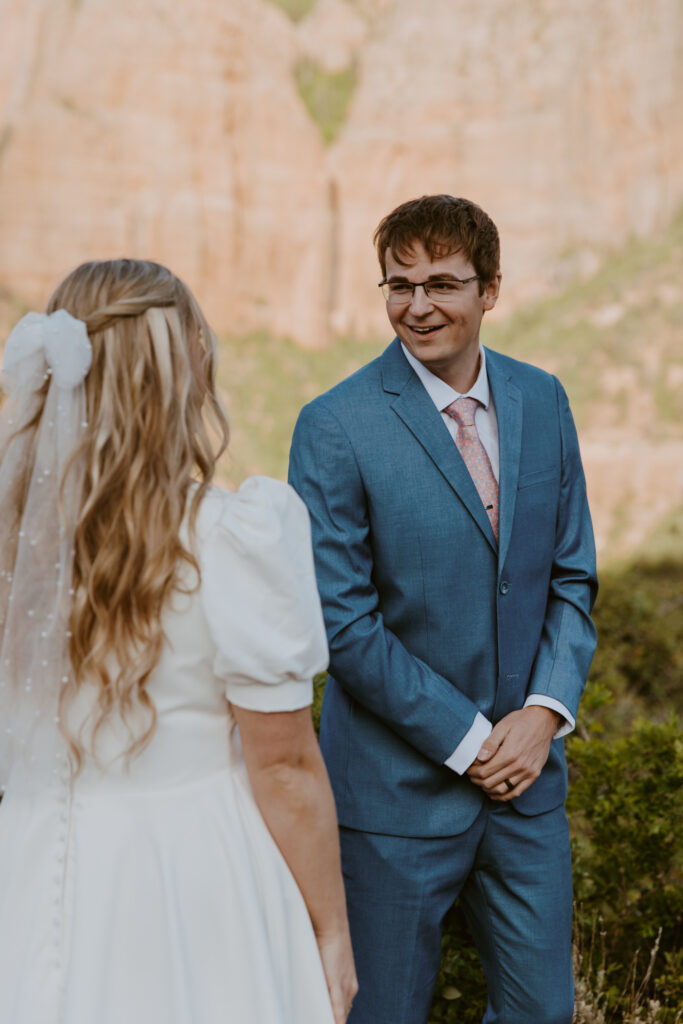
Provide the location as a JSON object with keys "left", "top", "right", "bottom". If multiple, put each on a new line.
{"left": 0, "top": 309, "right": 92, "bottom": 790}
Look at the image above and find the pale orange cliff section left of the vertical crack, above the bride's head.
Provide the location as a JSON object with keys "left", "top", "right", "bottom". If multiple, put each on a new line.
{"left": 0, "top": 0, "right": 329, "bottom": 340}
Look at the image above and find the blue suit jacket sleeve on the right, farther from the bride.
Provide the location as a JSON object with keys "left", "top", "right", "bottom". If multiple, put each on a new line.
{"left": 527, "top": 380, "right": 598, "bottom": 718}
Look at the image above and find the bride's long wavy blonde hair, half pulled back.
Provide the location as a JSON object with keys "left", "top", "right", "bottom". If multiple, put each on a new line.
{"left": 17, "top": 259, "right": 228, "bottom": 769}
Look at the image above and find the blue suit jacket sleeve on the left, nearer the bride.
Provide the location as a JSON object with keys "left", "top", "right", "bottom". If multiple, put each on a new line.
{"left": 289, "top": 402, "right": 485, "bottom": 764}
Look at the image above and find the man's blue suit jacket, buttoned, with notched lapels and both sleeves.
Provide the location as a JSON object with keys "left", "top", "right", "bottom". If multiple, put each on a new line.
{"left": 290, "top": 339, "right": 597, "bottom": 836}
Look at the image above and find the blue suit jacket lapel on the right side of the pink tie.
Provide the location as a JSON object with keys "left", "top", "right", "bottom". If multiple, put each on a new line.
{"left": 486, "top": 349, "right": 523, "bottom": 567}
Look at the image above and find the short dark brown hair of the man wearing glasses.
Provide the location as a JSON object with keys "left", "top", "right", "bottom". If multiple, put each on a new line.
{"left": 373, "top": 196, "right": 501, "bottom": 294}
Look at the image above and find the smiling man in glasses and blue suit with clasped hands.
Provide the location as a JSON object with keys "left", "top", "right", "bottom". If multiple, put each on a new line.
{"left": 290, "top": 196, "right": 596, "bottom": 1024}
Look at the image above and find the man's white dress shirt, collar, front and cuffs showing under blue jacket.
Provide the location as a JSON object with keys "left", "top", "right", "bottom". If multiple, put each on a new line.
{"left": 400, "top": 342, "right": 577, "bottom": 775}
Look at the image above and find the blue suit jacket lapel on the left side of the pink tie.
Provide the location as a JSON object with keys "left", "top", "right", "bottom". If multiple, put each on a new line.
{"left": 382, "top": 339, "right": 498, "bottom": 550}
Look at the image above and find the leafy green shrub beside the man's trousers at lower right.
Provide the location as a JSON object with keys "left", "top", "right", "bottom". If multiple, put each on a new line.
{"left": 567, "top": 717, "right": 683, "bottom": 1020}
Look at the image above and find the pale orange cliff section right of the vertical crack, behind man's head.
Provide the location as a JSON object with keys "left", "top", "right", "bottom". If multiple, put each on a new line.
{"left": 330, "top": 0, "right": 683, "bottom": 333}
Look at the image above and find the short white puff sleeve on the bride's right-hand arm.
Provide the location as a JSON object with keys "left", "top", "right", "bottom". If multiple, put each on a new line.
{"left": 200, "top": 476, "right": 328, "bottom": 712}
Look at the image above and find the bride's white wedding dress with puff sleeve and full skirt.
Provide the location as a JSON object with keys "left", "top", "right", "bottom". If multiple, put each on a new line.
{"left": 0, "top": 477, "right": 333, "bottom": 1024}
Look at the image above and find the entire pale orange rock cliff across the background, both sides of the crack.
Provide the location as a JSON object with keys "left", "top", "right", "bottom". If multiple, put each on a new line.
{"left": 0, "top": 0, "right": 683, "bottom": 345}
